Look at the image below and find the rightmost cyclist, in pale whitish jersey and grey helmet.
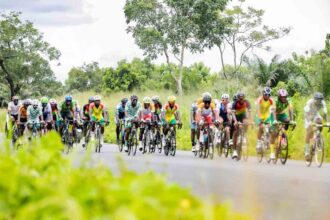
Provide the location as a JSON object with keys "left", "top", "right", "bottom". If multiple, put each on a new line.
{"left": 304, "top": 92, "right": 330, "bottom": 161}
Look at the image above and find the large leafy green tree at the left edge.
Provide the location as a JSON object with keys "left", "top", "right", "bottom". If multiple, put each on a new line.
{"left": 0, "top": 12, "right": 60, "bottom": 96}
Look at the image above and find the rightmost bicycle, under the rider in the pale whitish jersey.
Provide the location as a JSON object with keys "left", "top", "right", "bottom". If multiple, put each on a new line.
{"left": 306, "top": 124, "right": 330, "bottom": 167}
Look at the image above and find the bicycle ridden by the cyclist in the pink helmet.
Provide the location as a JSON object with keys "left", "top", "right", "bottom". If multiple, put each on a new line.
{"left": 273, "top": 122, "right": 296, "bottom": 165}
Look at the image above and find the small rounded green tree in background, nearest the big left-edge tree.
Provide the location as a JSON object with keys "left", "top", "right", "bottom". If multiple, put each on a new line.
{"left": 65, "top": 62, "right": 104, "bottom": 92}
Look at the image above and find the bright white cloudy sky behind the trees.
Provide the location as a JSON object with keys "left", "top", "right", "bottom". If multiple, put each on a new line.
{"left": 0, "top": 0, "right": 330, "bottom": 81}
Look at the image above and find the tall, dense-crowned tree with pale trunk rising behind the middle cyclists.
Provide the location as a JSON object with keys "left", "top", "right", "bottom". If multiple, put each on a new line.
{"left": 124, "top": 0, "right": 227, "bottom": 95}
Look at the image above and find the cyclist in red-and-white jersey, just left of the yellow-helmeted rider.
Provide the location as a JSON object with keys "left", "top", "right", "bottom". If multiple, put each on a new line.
{"left": 139, "top": 97, "right": 153, "bottom": 151}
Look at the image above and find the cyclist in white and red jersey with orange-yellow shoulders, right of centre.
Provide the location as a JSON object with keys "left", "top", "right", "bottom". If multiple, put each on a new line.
{"left": 196, "top": 92, "right": 219, "bottom": 150}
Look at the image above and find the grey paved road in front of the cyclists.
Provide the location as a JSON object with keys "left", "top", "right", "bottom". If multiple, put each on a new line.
{"left": 79, "top": 145, "right": 330, "bottom": 219}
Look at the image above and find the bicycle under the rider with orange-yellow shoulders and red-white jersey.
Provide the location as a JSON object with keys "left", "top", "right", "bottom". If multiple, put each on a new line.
{"left": 199, "top": 123, "right": 214, "bottom": 159}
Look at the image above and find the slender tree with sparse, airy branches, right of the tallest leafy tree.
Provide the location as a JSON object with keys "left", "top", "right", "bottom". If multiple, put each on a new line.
{"left": 205, "top": 0, "right": 290, "bottom": 79}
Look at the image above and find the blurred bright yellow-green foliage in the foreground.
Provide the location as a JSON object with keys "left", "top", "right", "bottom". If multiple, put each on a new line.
{"left": 0, "top": 133, "right": 247, "bottom": 219}
